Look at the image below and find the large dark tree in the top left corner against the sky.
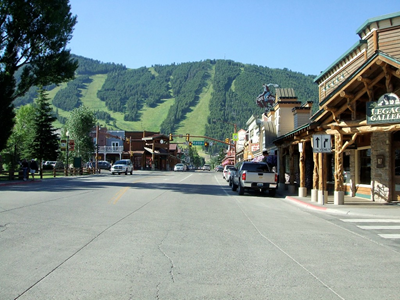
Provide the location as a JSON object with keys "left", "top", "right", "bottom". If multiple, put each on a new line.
{"left": 0, "top": 0, "right": 77, "bottom": 150}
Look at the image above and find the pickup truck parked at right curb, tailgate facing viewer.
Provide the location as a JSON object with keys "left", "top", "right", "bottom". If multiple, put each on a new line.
{"left": 232, "top": 161, "right": 278, "bottom": 197}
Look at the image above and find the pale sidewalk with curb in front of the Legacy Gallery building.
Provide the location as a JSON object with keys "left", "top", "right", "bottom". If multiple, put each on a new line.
{"left": 277, "top": 190, "right": 400, "bottom": 219}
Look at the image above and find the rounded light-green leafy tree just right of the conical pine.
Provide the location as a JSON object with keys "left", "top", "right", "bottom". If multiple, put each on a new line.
{"left": 66, "top": 106, "right": 97, "bottom": 161}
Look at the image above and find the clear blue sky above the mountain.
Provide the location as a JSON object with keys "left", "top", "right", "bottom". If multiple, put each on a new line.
{"left": 69, "top": 0, "right": 400, "bottom": 75}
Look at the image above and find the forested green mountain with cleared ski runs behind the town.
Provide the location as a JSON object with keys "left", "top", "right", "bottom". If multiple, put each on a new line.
{"left": 14, "top": 56, "right": 318, "bottom": 152}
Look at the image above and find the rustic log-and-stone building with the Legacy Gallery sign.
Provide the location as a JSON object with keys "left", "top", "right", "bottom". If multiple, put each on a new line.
{"left": 275, "top": 12, "right": 400, "bottom": 204}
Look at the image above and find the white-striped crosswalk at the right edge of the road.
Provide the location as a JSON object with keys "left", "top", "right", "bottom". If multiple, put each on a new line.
{"left": 340, "top": 218, "right": 400, "bottom": 240}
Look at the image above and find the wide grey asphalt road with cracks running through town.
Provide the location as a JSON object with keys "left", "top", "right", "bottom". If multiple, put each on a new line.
{"left": 0, "top": 171, "right": 400, "bottom": 300}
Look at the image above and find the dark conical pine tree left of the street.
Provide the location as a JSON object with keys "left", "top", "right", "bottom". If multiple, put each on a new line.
{"left": 32, "top": 87, "right": 59, "bottom": 173}
